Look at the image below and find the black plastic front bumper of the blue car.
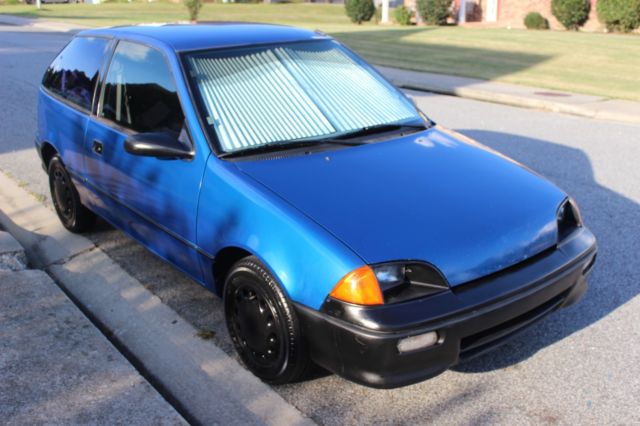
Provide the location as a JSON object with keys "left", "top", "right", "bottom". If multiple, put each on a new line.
{"left": 296, "top": 228, "right": 596, "bottom": 388}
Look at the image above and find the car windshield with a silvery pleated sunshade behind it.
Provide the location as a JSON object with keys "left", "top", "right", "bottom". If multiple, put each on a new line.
{"left": 185, "top": 39, "right": 423, "bottom": 153}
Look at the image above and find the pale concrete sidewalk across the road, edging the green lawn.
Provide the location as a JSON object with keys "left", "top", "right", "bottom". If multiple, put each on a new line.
{"left": 0, "top": 14, "right": 640, "bottom": 124}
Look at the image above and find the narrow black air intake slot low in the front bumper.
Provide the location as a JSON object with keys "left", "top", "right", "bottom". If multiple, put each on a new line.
{"left": 460, "top": 289, "right": 571, "bottom": 360}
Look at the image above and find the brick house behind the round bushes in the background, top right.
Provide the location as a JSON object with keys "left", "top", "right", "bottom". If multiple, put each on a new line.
{"left": 404, "top": 0, "right": 602, "bottom": 31}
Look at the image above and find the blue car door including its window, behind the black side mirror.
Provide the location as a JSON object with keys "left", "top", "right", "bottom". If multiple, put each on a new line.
{"left": 85, "top": 41, "right": 207, "bottom": 280}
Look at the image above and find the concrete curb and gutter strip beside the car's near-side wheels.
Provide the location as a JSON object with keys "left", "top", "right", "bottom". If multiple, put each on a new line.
{"left": 0, "top": 173, "right": 313, "bottom": 425}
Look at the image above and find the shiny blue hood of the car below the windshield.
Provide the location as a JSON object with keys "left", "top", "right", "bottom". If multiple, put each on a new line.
{"left": 236, "top": 127, "right": 566, "bottom": 286}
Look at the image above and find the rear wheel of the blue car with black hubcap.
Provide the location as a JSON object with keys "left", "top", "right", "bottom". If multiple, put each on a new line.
{"left": 48, "top": 155, "right": 96, "bottom": 233}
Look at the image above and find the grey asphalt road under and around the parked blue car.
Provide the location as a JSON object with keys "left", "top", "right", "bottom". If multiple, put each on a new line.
{"left": 0, "top": 26, "right": 640, "bottom": 424}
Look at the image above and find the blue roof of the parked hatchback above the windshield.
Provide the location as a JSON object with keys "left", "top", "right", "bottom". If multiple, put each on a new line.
{"left": 79, "top": 22, "right": 328, "bottom": 51}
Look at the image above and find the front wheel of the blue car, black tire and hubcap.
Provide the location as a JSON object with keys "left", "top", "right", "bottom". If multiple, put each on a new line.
{"left": 224, "top": 256, "right": 312, "bottom": 384}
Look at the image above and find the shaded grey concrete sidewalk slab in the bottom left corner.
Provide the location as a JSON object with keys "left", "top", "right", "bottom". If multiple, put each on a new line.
{"left": 0, "top": 231, "right": 186, "bottom": 425}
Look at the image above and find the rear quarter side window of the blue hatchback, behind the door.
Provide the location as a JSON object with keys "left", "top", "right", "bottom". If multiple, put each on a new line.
{"left": 42, "top": 37, "right": 109, "bottom": 110}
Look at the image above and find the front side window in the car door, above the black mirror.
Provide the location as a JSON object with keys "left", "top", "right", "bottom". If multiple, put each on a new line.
{"left": 100, "top": 41, "right": 184, "bottom": 134}
